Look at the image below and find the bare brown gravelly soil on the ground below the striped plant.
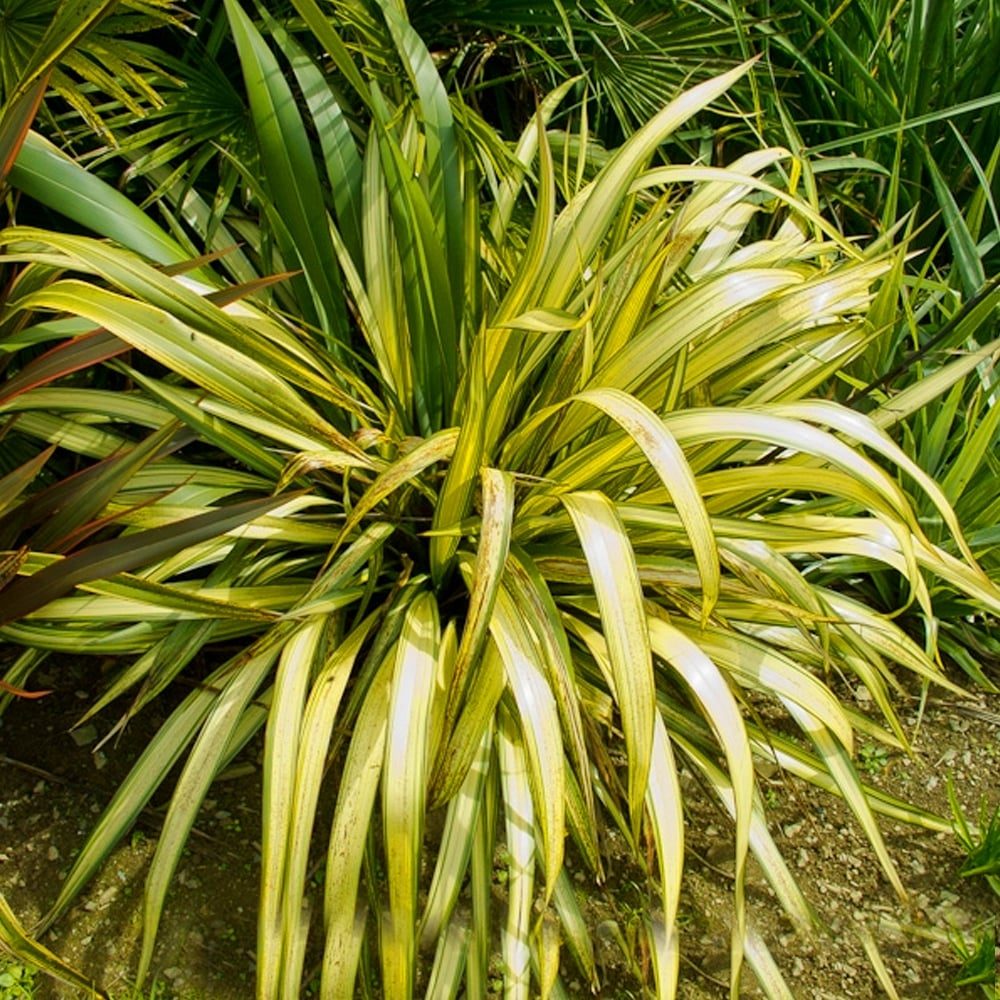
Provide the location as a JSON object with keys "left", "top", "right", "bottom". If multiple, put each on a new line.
{"left": 0, "top": 666, "right": 1000, "bottom": 1000}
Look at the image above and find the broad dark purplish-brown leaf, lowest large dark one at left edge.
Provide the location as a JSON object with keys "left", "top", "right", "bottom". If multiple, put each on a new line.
{"left": 0, "top": 493, "right": 299, "bottom": 625}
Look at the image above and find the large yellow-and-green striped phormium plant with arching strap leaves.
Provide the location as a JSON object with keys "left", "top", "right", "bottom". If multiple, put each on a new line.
{"left": 0, "top": 0, "right": 1000, "bottom": 1000}
